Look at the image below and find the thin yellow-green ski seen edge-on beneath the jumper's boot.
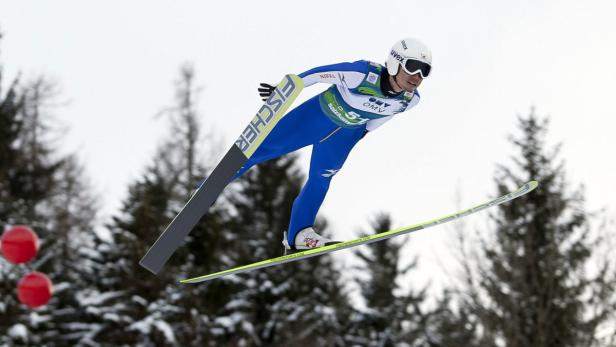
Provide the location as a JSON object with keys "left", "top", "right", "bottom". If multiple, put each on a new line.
{"left": 180, "top": 181, "right": 539, "bottom": 283}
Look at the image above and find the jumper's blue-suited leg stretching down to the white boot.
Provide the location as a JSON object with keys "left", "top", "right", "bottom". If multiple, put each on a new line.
{"left": 287, "top": 126, "right": 365, "bottom": 246}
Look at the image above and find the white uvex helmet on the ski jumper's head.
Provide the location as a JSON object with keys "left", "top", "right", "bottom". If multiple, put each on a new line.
{"left": 385, "top": 38, "right": 432, "bottom": 78}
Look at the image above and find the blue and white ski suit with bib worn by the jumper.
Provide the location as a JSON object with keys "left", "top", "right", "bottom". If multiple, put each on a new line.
{"left": 234, "top": 60, "right": 419, "bottom": 246}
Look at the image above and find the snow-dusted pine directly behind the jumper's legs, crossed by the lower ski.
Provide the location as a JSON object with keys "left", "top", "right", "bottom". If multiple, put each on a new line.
{"left": 209, "top": 155, "right": 350, "bottom": 346}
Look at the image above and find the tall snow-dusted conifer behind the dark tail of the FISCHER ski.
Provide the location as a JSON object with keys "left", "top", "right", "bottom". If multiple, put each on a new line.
{"left": 83, "top": 65, "right": 235, "bottom": 346}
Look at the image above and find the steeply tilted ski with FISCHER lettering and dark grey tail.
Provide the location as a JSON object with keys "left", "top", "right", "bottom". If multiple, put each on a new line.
{"left": 139, "top": 74, "right": 304, "bottom": 274}
